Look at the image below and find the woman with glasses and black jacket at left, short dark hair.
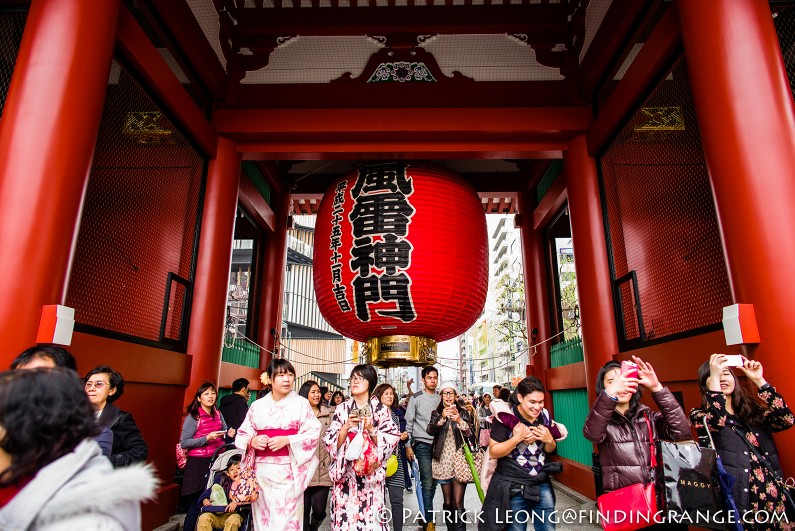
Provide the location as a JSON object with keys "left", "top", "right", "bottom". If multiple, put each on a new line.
{"left": 85, "top": 365, "right": 149, "bottom": 467}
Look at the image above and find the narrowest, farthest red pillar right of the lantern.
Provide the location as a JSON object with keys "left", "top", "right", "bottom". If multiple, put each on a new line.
{"left": 519, "top": 190, "right": 551, "bottom": 388}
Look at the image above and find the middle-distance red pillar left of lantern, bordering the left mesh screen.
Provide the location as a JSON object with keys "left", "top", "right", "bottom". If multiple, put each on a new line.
{"left": 185, "top": 138, "right": 240, "bottom": 402}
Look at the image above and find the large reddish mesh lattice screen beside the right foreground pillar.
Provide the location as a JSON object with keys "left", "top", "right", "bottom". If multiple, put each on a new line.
{"left": 599, "top": 59, "right": 732, "bottom": 348}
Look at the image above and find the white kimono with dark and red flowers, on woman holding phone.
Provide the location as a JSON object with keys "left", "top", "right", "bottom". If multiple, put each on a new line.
{"left": 323, "top": 398, "right": 403, "bottom": 531}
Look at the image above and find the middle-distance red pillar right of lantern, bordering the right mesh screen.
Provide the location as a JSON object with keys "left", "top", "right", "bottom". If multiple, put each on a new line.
{"left": 563, "top": 136, "right": 618, "bottom": 400}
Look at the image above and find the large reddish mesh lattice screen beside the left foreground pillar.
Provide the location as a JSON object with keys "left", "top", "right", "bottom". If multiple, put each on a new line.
{"left": 67, "top": 62, "right": 206, "bottom": 348}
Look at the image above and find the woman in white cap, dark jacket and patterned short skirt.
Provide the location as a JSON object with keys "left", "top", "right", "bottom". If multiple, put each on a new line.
{"left": 427, "top": 381, "right": 475, "bottom": 531}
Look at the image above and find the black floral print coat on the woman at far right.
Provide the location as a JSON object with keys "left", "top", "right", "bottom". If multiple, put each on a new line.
{"left": 690, "top": 384, "right": 795, "bottom": 530}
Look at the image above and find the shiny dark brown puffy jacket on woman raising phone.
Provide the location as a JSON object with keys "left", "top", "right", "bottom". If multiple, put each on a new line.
{"left": 582, "top": 387, "right": 692, "bottom": 492}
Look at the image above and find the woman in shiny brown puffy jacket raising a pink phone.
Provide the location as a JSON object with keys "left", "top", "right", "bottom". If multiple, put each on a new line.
{"left": 583, "top": 356, "right": 691, "bottom": 529}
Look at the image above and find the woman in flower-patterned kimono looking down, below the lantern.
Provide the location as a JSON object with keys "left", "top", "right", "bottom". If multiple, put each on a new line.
{"left": 323, "top": 365, "right": 403, "bottom": 531}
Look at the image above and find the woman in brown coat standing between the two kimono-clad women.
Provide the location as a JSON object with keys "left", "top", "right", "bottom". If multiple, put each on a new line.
{"left": 298, "top": 380, "right": 334, "bottom": 531}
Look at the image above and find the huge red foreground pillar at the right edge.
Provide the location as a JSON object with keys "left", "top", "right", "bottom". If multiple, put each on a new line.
{"left": 677, "top": 0, "right": 795, "bottom": 476}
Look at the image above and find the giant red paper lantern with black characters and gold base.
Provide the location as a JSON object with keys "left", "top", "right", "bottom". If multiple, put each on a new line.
{"left": 314, "top": 163, "right": 488, "bottom": 366}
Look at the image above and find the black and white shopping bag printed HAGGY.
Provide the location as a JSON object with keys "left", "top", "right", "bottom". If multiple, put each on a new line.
{"left": 657, "top": 441, "right": 727, "bottom": 529}
